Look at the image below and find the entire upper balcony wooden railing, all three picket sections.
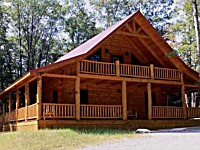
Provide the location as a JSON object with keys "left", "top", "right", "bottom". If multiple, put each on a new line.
{"left": 80, "top": 60, "right": 181, "bottom": 81}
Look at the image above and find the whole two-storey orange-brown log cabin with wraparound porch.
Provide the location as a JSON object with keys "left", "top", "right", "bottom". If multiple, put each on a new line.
{"left": 0, "top": 11, "right": 200, "bottom": 131}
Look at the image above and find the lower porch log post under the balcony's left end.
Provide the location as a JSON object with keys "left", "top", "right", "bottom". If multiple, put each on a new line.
{"left": 75, "top": 77, "right": 80, "bottom": 120}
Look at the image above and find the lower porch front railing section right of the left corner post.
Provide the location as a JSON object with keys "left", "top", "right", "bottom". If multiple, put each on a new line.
{"left": 43, "top": 103, "right": 75, "bottom": 119}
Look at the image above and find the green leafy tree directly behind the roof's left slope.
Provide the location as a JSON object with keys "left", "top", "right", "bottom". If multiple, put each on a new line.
{"left": 65, "top": 0, "right": 101, "bottom": 52}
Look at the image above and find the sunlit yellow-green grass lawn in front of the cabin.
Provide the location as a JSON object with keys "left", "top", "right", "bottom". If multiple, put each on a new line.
{"left": 0, "top": 129, "right": 136, "bottom": 150}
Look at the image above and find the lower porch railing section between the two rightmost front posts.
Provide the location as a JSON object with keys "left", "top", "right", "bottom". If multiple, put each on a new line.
{"left": 152, "top": 106, "right": 183, "bottom": 118}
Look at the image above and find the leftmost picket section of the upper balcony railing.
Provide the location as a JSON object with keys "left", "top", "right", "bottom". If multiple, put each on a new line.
{"left": 80, "top": 60, "right": 116, "bottom": 75}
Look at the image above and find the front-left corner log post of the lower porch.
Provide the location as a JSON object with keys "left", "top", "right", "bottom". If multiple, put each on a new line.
{"left": 37, "top": 75, "right": 42, "bottom": 120}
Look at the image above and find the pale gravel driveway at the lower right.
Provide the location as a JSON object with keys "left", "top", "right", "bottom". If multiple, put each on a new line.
{"left": 82, "top": 127, "right": 200, "bottom": 150}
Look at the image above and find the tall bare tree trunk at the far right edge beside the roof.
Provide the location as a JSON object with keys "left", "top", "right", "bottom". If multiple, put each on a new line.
{"left": 192, "top": 0, "right": 200, "bottom": 82}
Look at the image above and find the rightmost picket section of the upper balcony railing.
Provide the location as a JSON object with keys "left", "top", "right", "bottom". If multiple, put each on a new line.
{"left": 154, "top": 67, "right": 181, "bottom": 80}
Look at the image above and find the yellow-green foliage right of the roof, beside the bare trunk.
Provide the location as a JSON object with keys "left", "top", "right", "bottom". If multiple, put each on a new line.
{"left": 169, "top": 1, "right": 198, "bottom": 70}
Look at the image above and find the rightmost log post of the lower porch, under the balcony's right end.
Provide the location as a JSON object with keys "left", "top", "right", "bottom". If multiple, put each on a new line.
{"left": 181, "top": 73, "right": 187, "bottom": 119}
